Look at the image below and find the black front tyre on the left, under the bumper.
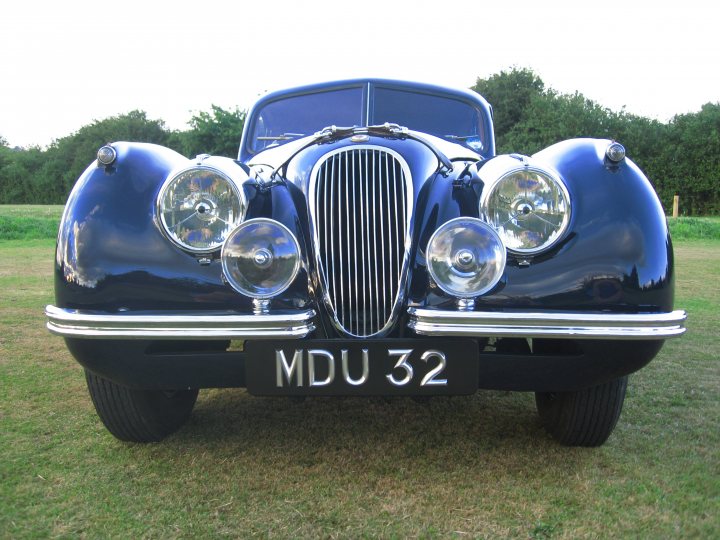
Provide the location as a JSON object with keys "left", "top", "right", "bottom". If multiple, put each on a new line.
{"left": 85, "top": 370, "right": 198, "bottom": 442}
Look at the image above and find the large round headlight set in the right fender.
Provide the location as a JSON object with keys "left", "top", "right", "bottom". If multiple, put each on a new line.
{"left": 480, "top": 162, "right": 570, "bottom": 254}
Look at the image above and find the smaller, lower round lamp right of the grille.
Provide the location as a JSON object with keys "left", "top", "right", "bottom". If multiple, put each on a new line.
{"left": 427, "top": 217, "right": 505, "bottom": 298}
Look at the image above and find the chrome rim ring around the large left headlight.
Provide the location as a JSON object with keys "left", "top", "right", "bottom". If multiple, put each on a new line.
{"left": 155, "top": 162, "right": 248, "bottom": 255}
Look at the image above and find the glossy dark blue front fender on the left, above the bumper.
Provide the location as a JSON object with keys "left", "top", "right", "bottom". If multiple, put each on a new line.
{"left": 50, "top": 142, "right": 307, "bottom": 313}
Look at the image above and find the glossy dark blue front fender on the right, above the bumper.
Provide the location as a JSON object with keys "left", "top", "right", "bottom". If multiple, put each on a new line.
{"left": 413, "top": 139, "right": 674, "bottom": 313}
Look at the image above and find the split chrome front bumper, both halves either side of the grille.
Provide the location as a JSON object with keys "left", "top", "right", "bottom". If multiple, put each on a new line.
{"left": 45, "top": 306, "right": 687, "bottom": 340}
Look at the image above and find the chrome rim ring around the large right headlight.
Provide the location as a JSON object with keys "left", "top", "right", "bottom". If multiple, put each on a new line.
{"left": 479, "top": 162, "right": 572, "bottom": 256}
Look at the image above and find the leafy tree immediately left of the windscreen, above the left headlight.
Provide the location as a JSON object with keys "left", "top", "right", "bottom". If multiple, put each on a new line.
{"left": 171, "top": 105, "right": 245, "bottom": 158}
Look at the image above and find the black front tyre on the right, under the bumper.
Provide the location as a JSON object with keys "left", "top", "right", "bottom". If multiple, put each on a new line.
{"left": 535, "top": 376, "right": 627, "bottom": 446}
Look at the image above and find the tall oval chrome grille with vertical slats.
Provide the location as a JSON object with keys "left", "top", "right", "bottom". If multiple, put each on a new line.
{"left": 308, "top": 145, "right": 414, "bottom": 337}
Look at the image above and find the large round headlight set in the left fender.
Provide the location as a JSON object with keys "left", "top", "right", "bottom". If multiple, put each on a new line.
{"left": 158, "top": 166, "right": 245, "bottom": 253}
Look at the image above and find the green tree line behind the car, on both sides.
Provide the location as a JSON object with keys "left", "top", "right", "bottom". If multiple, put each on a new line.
{"left": 0, "top": 68, "right": 720, "bottom": 215}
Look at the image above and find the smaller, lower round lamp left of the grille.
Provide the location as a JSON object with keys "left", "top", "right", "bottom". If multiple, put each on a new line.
{"left": 222, "top": 218, "right": 300, "bottom": 299}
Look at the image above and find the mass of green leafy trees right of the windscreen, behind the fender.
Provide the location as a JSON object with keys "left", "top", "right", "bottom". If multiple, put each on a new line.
{"left": 473, "top": 69, "right": 720, "bottom": 214}
